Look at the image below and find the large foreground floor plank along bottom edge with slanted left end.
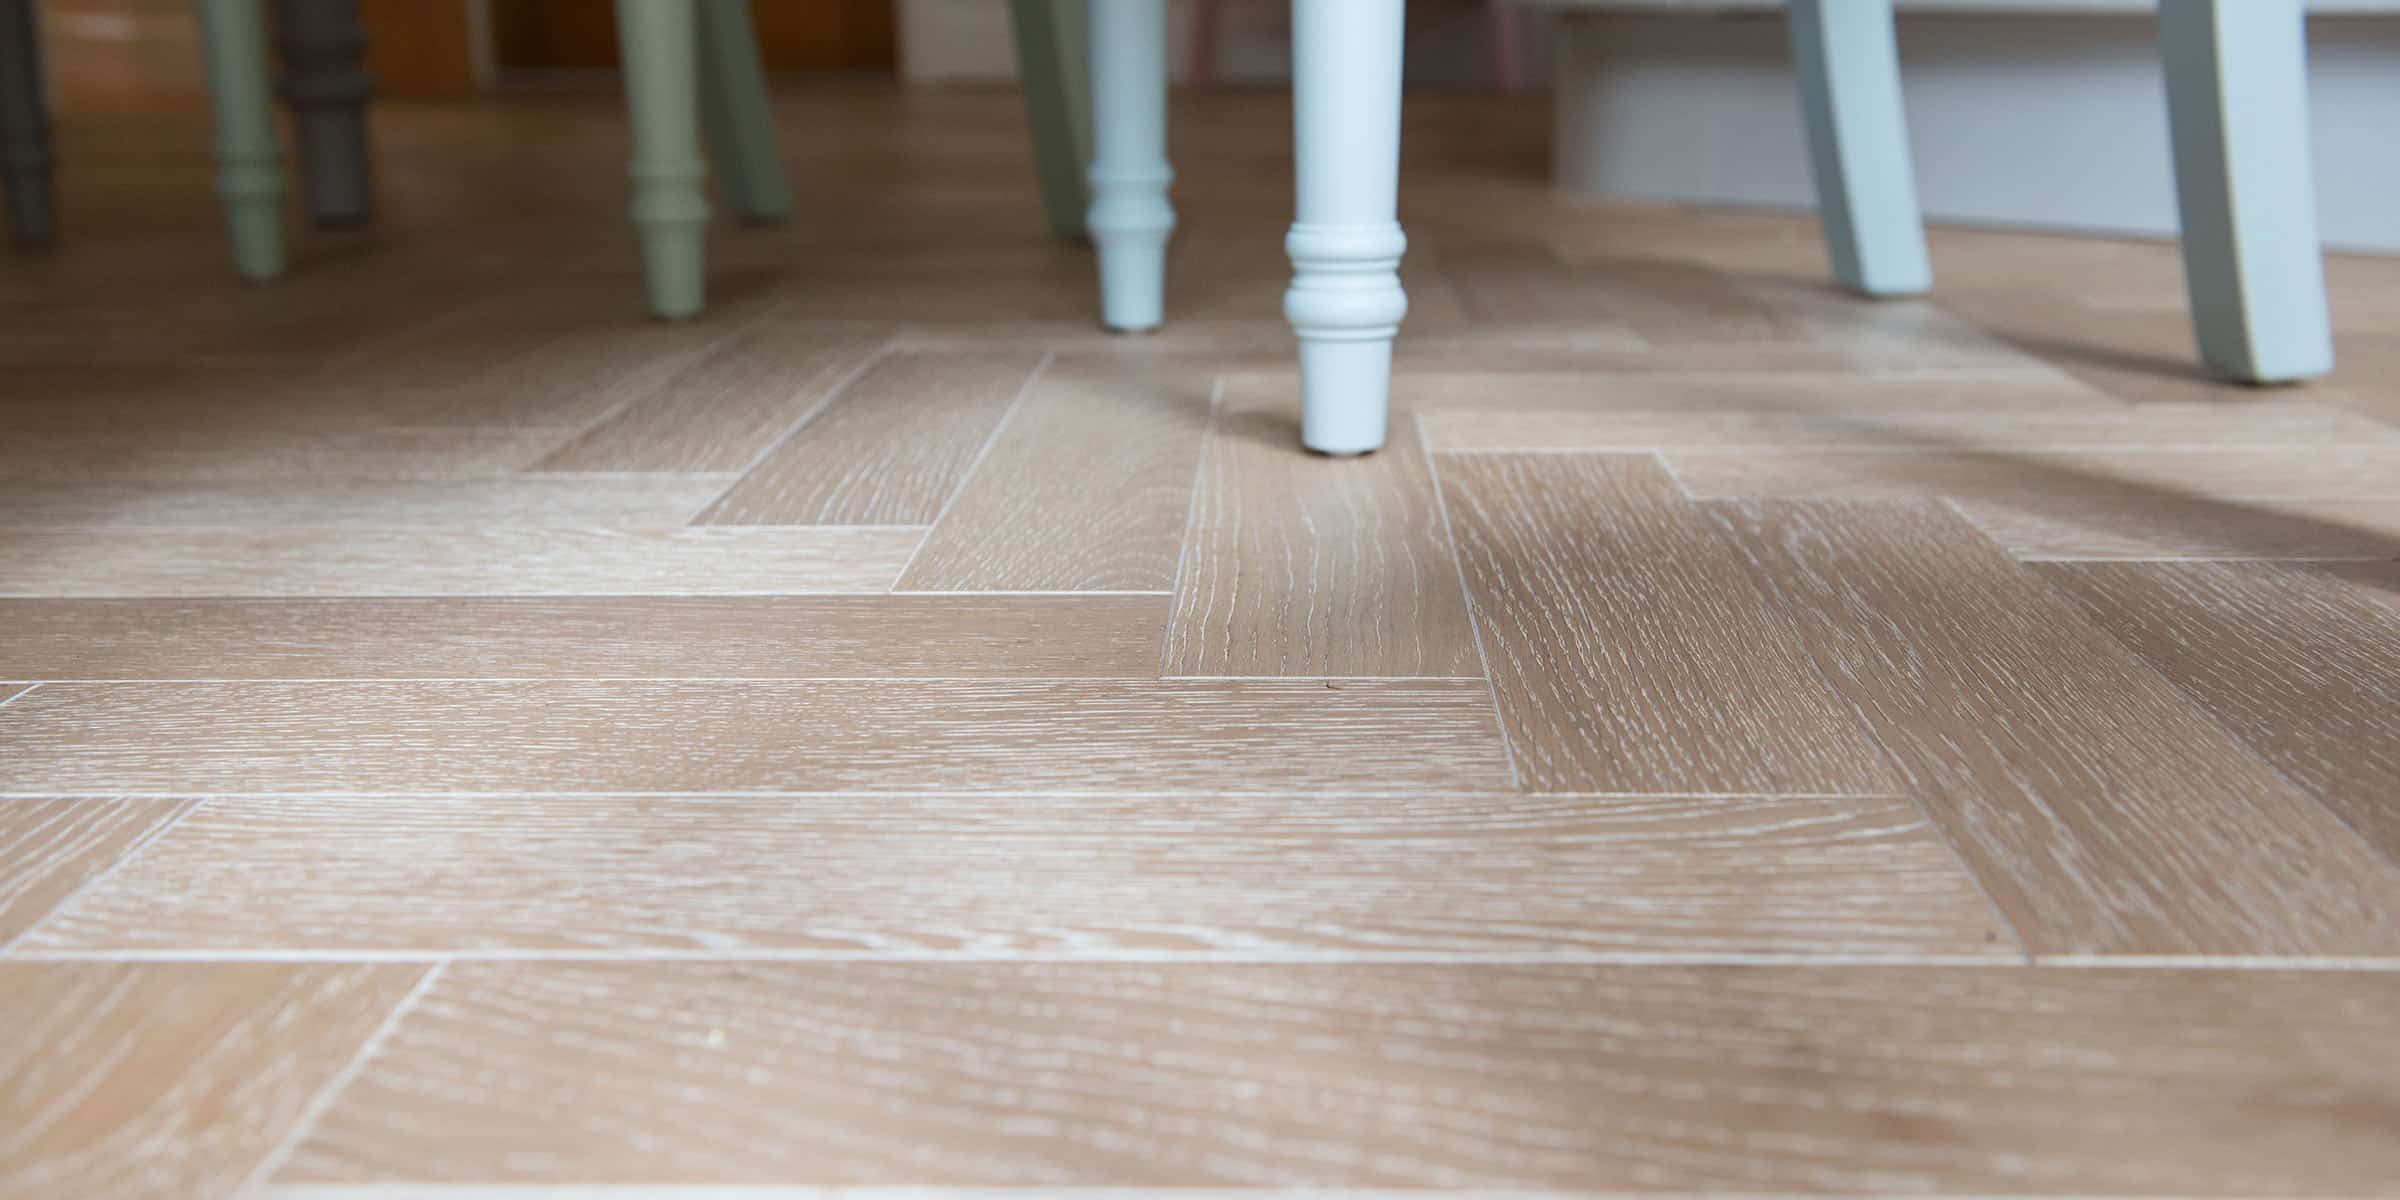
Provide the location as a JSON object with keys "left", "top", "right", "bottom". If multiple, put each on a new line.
{"left": 276, "top": 962, "right": 2400, "bottom": 1195}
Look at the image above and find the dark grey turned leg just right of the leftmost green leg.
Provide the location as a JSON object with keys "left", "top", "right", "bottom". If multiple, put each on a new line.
{"left": 276, "top": 0, "right": 374, "bottom": 228}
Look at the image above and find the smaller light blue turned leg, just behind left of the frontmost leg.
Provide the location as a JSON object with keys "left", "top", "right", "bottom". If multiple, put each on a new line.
{"left": 1085, "top": 0, "right": 1176, "bottom": 331}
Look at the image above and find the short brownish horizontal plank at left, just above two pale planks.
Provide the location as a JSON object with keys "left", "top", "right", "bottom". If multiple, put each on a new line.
{"left": 0, "top": 427, "right": 559, "bottom": 482}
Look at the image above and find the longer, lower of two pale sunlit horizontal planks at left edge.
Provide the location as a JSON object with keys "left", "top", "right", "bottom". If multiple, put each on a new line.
{"left": 0, "top": 526, "right": 924, "bottom": 598}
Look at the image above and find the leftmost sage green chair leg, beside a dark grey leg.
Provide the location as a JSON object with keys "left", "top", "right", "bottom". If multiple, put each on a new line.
{"left": 197, "top": 0, "right": 283, "bottom": 281}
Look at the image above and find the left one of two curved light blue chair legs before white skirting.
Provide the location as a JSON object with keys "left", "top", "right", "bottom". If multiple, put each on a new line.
{"left": 1788, "top": 0, "right": 1934, "bottom": 295}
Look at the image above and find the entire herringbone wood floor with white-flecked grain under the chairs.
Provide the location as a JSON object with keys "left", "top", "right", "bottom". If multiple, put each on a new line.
{"left": 0, "top": 86, "right": 2400, "bottom": 1200}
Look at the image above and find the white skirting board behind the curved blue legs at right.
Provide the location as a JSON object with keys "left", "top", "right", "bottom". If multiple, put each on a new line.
{"left": 1553, "top": 12, "right": 2400, "bottom": 252}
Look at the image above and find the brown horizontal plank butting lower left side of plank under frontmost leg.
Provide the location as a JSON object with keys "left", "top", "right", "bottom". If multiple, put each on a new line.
{"left": 0, "top": 595, "right": 1169, "bottom": 679}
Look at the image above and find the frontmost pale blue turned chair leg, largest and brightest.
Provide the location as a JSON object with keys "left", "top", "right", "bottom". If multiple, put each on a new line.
{"left": 1284, "top": 0, "right": 1409, "bottom": 454}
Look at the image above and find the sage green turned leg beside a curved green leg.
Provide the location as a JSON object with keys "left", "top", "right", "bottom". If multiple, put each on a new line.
{"left": 617, "top": 0, "right": 708, "bottom": 319}
